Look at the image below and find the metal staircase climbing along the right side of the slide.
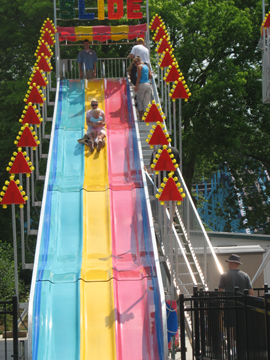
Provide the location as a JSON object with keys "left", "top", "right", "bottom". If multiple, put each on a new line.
{"left": 133, "top": 94, "right": 213, "bottom": 300}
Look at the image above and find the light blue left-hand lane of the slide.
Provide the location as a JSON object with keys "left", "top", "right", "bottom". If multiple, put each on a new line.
{"left": 32, "top": 80, "right": 85, "bottom": 360}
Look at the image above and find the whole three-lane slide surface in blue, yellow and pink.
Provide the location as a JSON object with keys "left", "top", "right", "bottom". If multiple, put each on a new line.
{"left": 29, "top": 79, "right": 166, "bottom": 360}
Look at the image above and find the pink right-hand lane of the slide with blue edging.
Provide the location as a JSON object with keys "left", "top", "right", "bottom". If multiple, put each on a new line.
{"left": 105, "top": 79, "right": 160, "bottom": 360}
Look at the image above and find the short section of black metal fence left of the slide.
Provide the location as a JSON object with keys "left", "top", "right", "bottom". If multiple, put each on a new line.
{"left": 0, "top": 296, "right": 19, "bottom": 360}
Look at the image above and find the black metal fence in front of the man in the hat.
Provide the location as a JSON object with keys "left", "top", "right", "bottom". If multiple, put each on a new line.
{"left": 180, "top": 287, "right": 270, "bottom": 360}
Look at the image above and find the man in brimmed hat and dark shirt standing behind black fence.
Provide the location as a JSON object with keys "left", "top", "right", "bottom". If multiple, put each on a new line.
{"left": 219, "top": 254, "right": 254, "bottom": 295}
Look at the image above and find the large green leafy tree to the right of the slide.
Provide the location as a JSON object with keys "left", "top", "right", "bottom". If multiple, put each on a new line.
{"left": 150, "top": 0, "right": 270, "bottom": 231}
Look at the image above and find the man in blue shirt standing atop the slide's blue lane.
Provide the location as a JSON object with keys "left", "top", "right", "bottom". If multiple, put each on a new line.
{"left": 77, "top": 39, "right": 98, "bottom": 80}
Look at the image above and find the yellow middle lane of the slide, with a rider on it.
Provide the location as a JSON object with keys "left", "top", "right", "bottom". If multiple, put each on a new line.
{"left": 80, "top": 80, "right": 116, "bottom": 360}
